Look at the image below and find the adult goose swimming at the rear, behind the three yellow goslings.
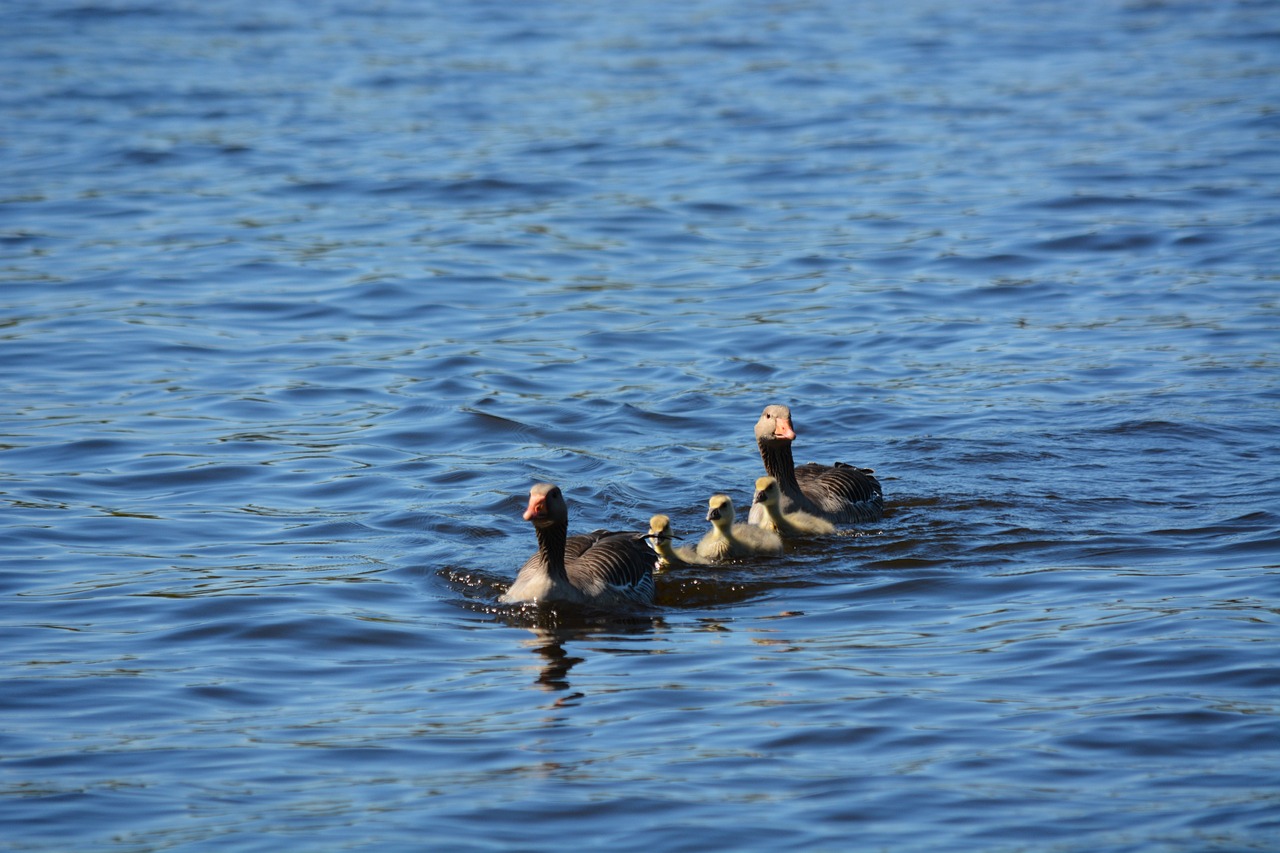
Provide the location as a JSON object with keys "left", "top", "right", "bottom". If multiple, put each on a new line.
{"left": 749, "top": 405, "right": 884, "bottom": 524}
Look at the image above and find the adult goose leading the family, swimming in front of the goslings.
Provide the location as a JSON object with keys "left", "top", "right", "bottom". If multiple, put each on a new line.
{"left": 499, "top": 483, "right": 657, "bottom": 606}
